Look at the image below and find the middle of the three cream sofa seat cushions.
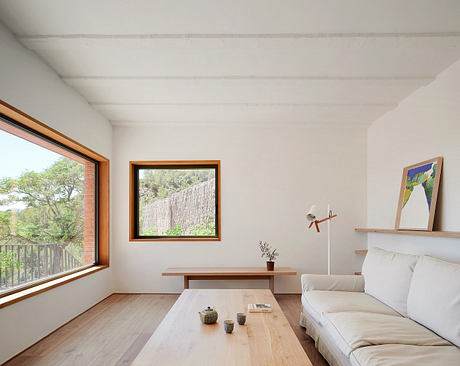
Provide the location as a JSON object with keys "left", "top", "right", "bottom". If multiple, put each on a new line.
{"left": 325, "top": 312, "right": 451, "bottom": 356}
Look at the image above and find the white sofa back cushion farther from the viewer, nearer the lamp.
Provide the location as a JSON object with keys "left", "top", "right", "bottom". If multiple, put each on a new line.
{"left": 362, "top": 247, "right": 418, "bottom": 316}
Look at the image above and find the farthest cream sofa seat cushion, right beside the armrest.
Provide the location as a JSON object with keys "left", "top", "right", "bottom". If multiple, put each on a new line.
{"left": 302, "top": 291, "right": 400, "bottom": 324}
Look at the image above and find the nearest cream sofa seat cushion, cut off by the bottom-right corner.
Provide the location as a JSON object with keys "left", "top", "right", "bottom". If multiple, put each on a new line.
{"left": 350, "top": 344, "right": 460, "bottom": 366}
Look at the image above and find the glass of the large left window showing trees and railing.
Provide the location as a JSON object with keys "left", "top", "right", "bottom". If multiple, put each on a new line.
{"left": 0, "top": 119, "right": 97, "bottom": 294}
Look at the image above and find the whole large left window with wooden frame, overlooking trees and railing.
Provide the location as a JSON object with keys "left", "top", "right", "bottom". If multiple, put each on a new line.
{"left": 0, "top": 102, "right": 109, "bottom": 307}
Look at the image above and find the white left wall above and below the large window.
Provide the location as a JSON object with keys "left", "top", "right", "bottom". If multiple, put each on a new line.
{"left": 0, "top": 24, "right": 112, "bottom": 364}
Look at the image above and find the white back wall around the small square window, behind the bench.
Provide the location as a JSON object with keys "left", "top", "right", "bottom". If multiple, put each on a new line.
{"left": 113, "top": 124, "right": 366, "bottom": 292}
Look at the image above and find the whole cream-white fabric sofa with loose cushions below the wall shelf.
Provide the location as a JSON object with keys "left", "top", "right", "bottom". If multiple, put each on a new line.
{"left": 300, "top": 248, "right": 460, "bottom": 366}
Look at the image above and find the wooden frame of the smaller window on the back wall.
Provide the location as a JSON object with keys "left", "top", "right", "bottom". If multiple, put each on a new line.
{"left": 129, "top": 160, "right": 222, "bottom": 242}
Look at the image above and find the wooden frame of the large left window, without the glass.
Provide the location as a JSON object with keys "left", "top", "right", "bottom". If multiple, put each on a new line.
{"left": 0, "top": 100, "right": 110, "bottom": 308}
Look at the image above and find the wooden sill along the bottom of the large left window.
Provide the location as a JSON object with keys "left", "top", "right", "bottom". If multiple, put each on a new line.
{"left": 0, "top": 266, "right": 109, "bottom": 308}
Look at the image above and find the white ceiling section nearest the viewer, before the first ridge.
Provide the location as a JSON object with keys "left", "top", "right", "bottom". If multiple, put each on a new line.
{"left": 0, "top": 0, "right": 460, "bottom": 36}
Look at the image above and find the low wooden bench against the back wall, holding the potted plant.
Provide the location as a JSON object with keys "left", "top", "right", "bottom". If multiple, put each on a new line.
{"left": 162, "top": 267, "right": 297, "bottom": 293}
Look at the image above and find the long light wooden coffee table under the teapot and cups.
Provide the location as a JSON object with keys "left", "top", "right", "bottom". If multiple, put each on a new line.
{"left": 132, "top": 289, "right": 311, "bottom": 366}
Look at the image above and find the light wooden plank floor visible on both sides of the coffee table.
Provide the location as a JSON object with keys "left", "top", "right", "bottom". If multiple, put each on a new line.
{"left": 4, "top": 294, "right": 327, "bottom": 366}
